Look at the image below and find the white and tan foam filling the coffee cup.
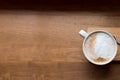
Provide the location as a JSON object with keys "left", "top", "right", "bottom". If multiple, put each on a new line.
{"left": 85, "top": 32, "right": 115, "bottom": 62}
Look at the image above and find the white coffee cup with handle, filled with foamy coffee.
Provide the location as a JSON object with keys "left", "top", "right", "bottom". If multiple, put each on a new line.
{"left": 79, "top": 30, "right": 117, "bottom": 65}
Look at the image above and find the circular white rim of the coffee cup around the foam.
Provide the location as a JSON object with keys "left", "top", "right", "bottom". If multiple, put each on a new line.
{"left": 82, "top": 30, "right": 118, "bottom": 65}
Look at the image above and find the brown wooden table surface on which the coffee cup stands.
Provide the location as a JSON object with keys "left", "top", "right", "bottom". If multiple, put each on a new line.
{"left": 0, "top": 10, "right": 120, "bottom": 80}
